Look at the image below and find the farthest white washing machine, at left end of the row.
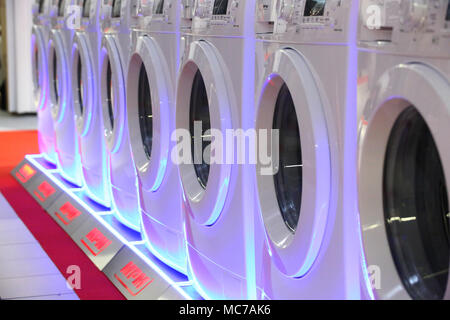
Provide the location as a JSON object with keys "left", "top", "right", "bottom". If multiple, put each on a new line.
{"left": 31, "top": 0, "right": 57, "bottom": 164}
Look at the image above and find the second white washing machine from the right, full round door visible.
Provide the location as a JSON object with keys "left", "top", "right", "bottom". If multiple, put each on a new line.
{"left": 254, "top": 0, "right": 362, "bottom": 299}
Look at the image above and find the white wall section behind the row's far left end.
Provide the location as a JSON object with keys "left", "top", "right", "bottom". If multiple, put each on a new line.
{"left": 6, "top": 0, "right": 36, "bottom": 113}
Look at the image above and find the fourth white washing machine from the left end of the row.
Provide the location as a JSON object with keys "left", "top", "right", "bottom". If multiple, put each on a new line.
{"left": 99, "top": 0, "right": 141, "bottom": 231}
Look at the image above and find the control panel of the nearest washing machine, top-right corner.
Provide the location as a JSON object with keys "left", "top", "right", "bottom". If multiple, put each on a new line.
{"left": 359, "top": 0, "right": 450, "bottom": 57}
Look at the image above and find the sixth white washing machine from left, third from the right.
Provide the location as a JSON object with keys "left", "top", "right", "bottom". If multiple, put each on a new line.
{"left": 175, "top": 0, "right": 256, "bottom": 299}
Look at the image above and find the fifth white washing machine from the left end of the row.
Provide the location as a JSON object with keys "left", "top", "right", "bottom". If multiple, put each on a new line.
{"left": 127, "top": 0, "right": 186, "bottom": 273}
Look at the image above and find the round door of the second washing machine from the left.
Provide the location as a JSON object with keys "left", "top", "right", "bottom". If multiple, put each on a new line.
{"left": 48, "top": 30, "right": 71, "bottom": 123}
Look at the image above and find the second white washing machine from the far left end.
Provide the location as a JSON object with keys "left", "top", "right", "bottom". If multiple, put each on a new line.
{"left": 48, "top": 0, "right": 83, "bottom": 186}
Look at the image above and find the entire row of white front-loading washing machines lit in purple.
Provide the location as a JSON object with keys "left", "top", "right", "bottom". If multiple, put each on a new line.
{"left": 32, "top": 0, "right": 450, "bottom": 299}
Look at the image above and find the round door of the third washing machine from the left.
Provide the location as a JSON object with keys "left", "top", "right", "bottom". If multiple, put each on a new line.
{"left": 71, "top": 33, "right": 96, "bottom": 136}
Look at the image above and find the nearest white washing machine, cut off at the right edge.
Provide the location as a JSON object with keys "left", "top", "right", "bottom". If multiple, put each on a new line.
{"left": 358, "top": 0, "right": 450, "bottom": 300}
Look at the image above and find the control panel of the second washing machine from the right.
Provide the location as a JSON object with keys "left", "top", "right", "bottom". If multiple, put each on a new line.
{"left": 274, "top": 0, "right": 357, "bottom": 42}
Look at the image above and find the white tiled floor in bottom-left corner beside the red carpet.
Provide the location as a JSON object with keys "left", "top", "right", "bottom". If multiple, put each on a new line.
{"left": 0, "top": 194, "right": 78, "bottom": 300}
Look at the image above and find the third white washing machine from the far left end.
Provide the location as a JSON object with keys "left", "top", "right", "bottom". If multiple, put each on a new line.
{"left": 71, "top": 0, "right": 111, "bottom": 207}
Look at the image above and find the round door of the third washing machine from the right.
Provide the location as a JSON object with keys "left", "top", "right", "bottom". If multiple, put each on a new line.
{"left": 176, "top": 41, "right": 236, "bottom": 226}
